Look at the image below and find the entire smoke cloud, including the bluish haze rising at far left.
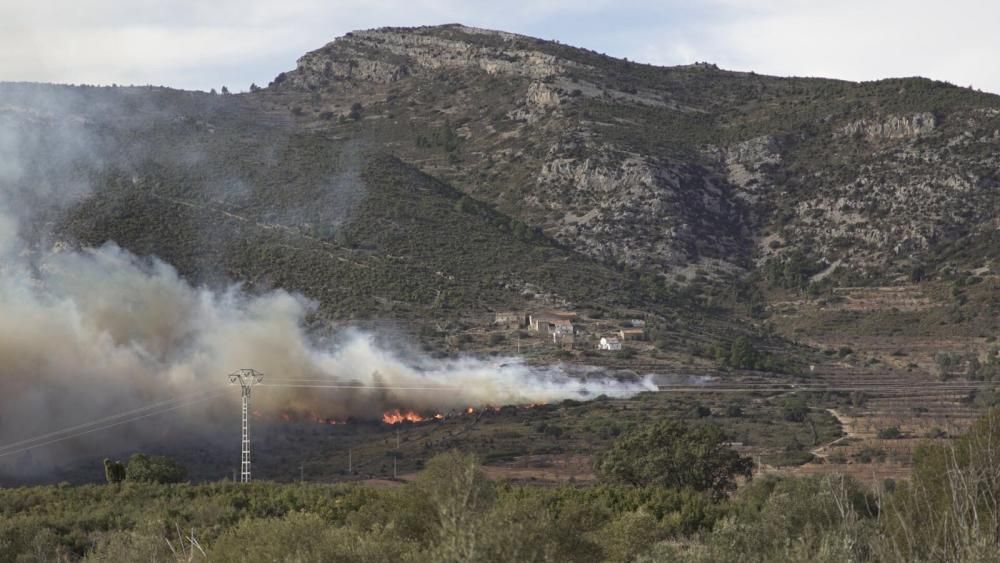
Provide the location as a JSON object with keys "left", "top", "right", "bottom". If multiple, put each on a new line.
{"left": 0, "top": 82, "right": 655, "bottom": 469}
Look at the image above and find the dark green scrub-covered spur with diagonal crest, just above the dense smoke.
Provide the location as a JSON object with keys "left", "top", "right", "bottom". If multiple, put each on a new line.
{"left": 58, "top": 150, "right": 642, "bottom": 319}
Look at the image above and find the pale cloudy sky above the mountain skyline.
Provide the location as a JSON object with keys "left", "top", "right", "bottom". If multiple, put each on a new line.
{"left": 0, "top": 0, "right": 1000, "bottom": 93}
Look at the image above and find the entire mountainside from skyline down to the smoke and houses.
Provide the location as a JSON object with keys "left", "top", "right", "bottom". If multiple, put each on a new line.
{"left": 0, "top": 25, "right": 1000, "bottom": 338}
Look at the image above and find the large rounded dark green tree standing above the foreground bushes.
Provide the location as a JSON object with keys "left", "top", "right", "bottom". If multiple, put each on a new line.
{"left": 595, "top": 420, "right": 753, "bottom": 498}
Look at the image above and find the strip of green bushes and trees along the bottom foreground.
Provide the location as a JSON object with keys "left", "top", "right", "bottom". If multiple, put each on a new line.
{"left": 0, "top": 411, "right": 1000, "bottom": 561}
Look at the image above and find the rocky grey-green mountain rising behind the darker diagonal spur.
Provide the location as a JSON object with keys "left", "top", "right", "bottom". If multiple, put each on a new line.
{"left": 261, "top": 26, "right": 1000, "bottom": 281}
